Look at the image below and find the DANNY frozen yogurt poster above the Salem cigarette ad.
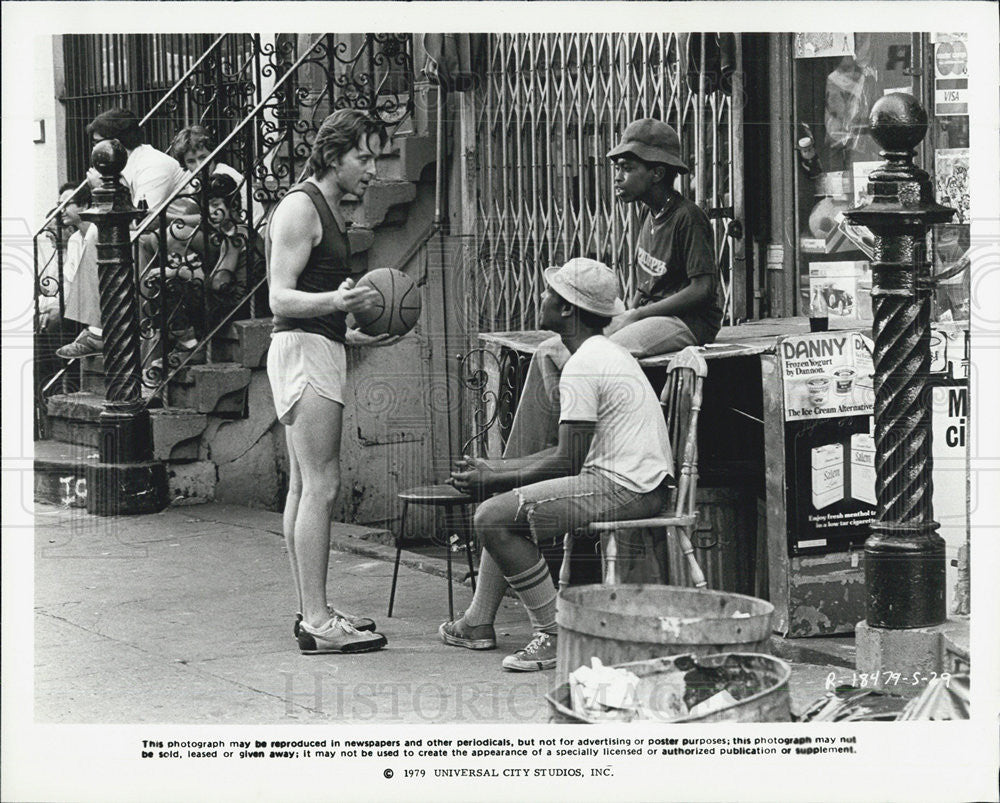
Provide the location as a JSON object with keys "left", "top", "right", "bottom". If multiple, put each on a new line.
{"left": 778, "top": 332, "right": 875, "bottom": 421}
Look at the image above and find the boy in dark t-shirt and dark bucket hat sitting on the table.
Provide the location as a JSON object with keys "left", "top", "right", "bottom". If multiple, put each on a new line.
{"left": 504, "top": 118, "right": 722, "bottom": 457}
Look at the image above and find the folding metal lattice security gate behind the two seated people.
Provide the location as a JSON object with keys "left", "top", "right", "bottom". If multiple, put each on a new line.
{"left": 469, "top": 33, "right": 743, "bottom": 331}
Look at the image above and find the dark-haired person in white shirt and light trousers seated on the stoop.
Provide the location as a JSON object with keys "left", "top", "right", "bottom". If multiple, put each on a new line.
{"left": 56, "top": 108, "right": 198, "bottom": 360}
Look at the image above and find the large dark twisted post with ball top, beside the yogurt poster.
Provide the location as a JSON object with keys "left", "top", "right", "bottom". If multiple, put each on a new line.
{"left": 845, "top": 93, "right": 955, "bottom": 628}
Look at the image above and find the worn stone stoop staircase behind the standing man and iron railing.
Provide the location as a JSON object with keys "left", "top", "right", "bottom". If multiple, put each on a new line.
{"left": 34, "top": 42, "right": 437, "bottom": 507}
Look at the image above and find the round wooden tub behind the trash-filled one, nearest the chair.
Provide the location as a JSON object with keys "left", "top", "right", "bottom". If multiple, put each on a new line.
{"left": 556, "top": 585, "right": 774, "bottom": 685}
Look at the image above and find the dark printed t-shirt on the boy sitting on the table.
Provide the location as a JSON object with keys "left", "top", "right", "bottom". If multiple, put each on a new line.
{"left": 635, "top": 193, "right": 722, "bottom": 343}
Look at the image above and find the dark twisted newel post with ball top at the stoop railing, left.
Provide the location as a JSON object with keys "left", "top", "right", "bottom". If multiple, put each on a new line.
{"left": 81, "top": 140, "right": 168, "bottom": 516}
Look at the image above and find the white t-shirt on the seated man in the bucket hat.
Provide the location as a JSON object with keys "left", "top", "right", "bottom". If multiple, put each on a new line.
{"left": 559, "top": 335, "right": 674, "bottom": 493}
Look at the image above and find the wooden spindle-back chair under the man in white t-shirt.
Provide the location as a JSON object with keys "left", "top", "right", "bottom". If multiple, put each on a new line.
{"left": 559, "top": 346, "right": 708, "bottom": 590}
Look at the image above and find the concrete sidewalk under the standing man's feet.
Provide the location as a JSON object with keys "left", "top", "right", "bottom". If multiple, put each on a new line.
{"left": 35, "top": 504, "right": 849, "bottom": 724}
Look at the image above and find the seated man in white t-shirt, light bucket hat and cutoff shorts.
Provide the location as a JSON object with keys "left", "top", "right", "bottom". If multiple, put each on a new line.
{"left": 439, "top": 258, "right": 673, "bottom": 672}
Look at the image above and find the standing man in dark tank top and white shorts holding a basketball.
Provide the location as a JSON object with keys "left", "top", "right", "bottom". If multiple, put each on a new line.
{"left": 265, "top": 109, "right": 399, "bottom": 654}
